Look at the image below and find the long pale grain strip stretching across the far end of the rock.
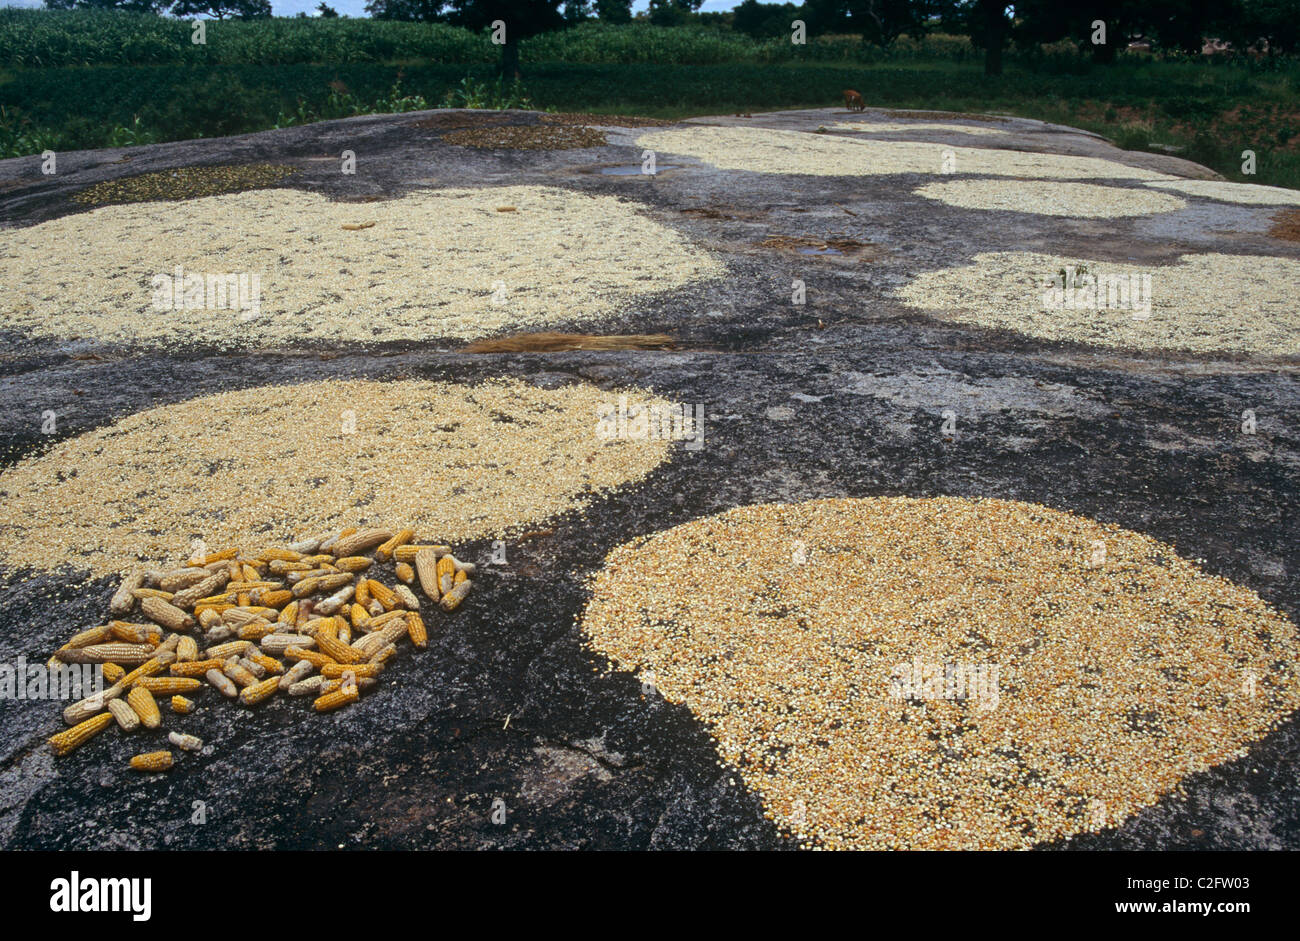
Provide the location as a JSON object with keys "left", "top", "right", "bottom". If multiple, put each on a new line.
{"left": 637, "top": 126, "right": 1171, "bottom": 186}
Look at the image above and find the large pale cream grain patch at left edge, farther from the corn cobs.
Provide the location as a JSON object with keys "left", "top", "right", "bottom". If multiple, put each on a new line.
{"left": 0, "top": 186, "right": 725, "bottom": 347}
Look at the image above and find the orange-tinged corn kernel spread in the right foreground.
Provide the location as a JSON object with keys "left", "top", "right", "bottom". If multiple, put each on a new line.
{"left": 581, "top": 498, "right": 1300, "bottom": 849}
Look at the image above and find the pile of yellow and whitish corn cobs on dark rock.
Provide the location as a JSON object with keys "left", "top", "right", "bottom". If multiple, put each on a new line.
{"left": 49, "top": 529, "right": 475, "bottom": 771}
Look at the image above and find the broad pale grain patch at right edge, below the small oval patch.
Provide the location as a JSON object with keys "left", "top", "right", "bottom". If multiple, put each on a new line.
{"left": 897, "top": 252, "right": 1300, "bottom": 356}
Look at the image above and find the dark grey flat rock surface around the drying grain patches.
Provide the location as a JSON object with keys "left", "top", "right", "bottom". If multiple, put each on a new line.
{"left": 0, "top": 109, "right": 1300, "bottom": 849}
